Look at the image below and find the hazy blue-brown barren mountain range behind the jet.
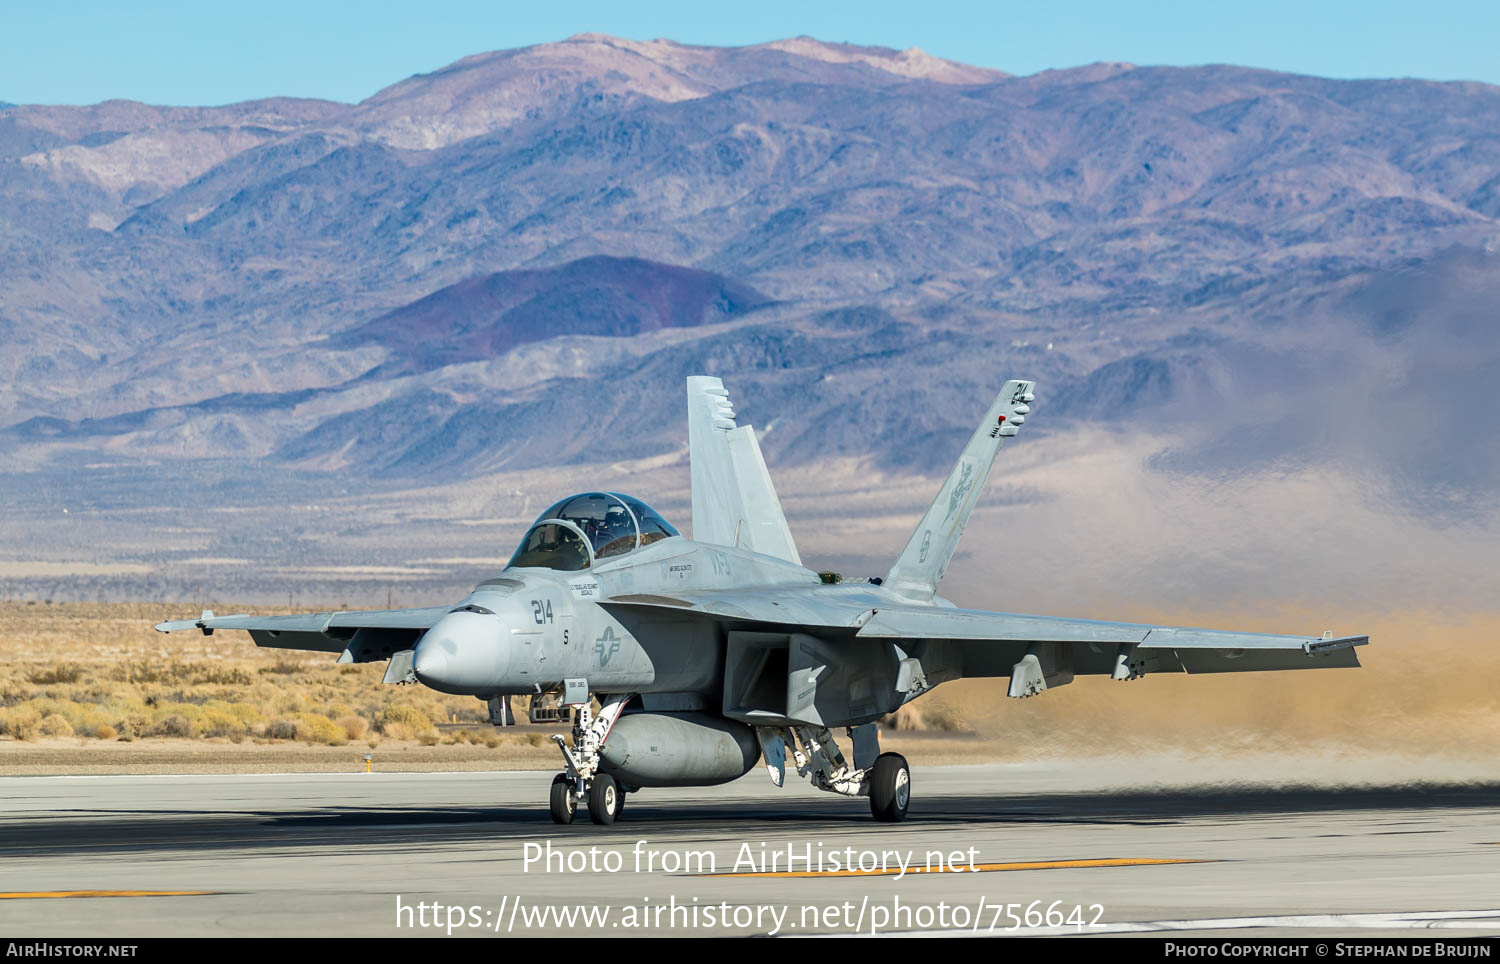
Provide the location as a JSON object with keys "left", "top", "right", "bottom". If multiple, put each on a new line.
{"left": 0, "top": 34, "right": 1500, "bottom": 596}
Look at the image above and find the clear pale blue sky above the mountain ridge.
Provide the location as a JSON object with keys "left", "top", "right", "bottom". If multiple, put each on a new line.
{"left": 0, "top": 0, "right": 1500, "bottom": 105}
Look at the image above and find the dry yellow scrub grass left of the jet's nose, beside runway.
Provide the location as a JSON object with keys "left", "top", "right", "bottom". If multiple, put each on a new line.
{"left": 0, "top": 603, "right": 531, "bottom": 768}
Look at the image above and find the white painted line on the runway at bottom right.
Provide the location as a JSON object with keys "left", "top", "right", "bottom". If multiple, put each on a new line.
{"left": 864, "top": 910, "right": 1500, "bottom": 937}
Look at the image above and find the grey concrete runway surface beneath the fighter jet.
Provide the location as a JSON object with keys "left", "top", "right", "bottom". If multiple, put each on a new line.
{"left": 0, "top": 765, "right": 1500, "bottom": 937}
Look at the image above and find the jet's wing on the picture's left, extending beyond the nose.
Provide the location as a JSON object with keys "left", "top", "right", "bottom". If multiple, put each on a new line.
{"left": 156, "top": 606, "right": 453, "bottom": 663}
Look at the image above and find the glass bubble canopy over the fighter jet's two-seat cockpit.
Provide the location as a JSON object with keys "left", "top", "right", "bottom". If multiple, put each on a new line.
{"left": 506, "top": 492, "right": 678, "bottom": 571}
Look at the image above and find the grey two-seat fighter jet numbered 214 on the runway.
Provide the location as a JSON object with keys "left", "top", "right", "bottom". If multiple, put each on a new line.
{"left": 156, "top": 376, "right": 1370, "bottom": 823}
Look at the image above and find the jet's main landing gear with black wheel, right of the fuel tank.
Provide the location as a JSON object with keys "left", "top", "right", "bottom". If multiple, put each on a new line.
{"left": 756, "top": 723, "right": 912, "bottom": 823}
